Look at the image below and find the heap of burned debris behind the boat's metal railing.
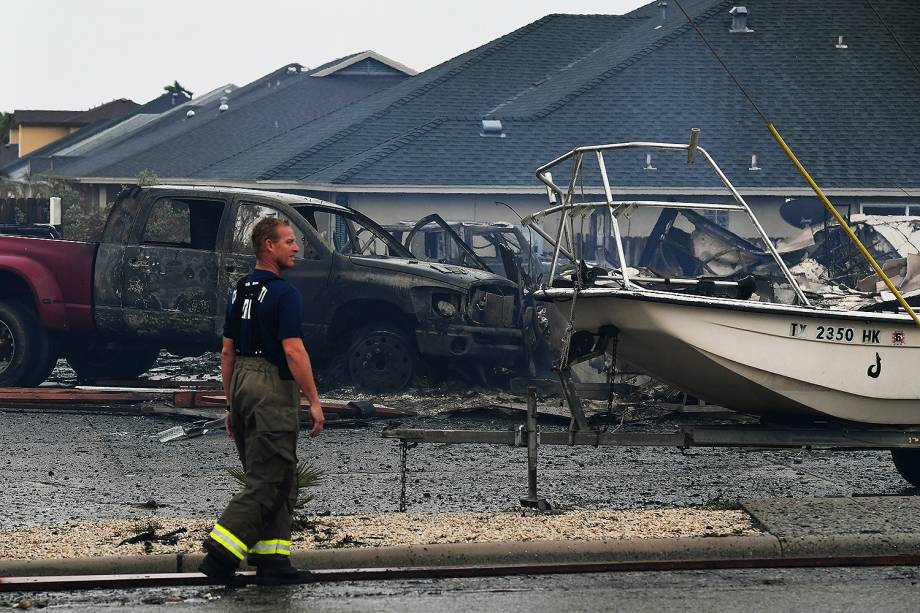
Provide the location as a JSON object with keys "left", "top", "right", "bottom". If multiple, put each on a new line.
{"left": 596, "top": 209, "right": 920, "bottom": 311}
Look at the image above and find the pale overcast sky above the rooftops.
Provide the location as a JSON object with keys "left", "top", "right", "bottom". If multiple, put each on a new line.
{"left": 0, "top": 0, "right": 650, "bottom": 112}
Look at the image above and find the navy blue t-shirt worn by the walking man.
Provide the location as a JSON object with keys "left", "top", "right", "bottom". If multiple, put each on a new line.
{"left": 224, "top": 270, "right": 303, "bottom": 366}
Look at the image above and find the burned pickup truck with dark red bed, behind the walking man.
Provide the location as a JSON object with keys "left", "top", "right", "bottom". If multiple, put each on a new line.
{"left": 0, "top": 186, "right": 526, "bottom": 390}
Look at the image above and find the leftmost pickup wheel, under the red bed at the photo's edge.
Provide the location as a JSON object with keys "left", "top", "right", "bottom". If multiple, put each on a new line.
{"left": 0, "top": 301, "right": 51, "bottom": 387}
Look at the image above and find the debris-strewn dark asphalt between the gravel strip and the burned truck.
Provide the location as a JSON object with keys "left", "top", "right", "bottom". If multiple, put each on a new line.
{"left": 0, "top": 410, "right": 916, "bottom": 528}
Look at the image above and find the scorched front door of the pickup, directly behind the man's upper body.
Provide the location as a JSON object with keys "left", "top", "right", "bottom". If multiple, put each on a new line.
{"left": 217, "top": 198, "right": 332, "bottom": 349}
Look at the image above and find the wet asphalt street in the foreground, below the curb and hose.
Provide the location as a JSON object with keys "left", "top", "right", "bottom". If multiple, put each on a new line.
{"left": 7, "top": 567, "right": 920, "bottom": 613}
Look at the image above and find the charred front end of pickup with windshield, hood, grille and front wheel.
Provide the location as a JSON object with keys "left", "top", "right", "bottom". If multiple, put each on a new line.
{"left": 293, "top": 200, "right": 525, "bottom": 389}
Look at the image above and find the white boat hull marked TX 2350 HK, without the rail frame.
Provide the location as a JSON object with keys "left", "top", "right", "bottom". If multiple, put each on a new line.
{"left": 537, "top": 288, "right": 920, "bottom": 425}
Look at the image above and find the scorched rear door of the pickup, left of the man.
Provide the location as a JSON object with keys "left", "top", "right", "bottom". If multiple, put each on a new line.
{"left": 122, "top": 195, "right": 226, "bottom": 343}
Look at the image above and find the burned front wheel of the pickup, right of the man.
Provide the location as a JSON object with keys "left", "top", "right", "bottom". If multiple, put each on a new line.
{"left": 345, "top": 324, "right": 418, "bottom": 392}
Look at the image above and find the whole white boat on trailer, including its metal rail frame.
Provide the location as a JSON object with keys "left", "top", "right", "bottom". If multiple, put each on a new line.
{"left": 524, "top": 137, "right": 920, "bottom": 425}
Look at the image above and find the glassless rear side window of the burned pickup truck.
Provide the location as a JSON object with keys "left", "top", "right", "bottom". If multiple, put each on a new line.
{"left": 140, "top": 196, "right": 227, "bottom": 251}
